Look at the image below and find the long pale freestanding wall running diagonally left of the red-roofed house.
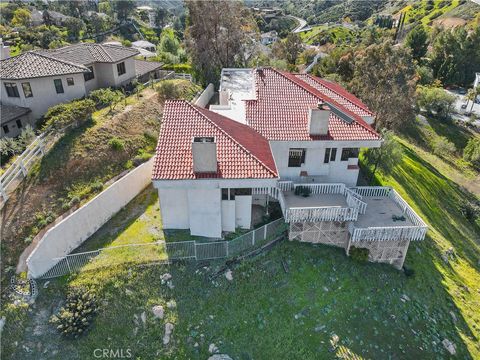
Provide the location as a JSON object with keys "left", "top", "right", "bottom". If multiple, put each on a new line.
{"left": 27, "top": 159, "right": 153, "bottom": 278}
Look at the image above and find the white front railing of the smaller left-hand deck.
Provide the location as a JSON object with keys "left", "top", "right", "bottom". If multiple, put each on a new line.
{"left": 285, "top": 206, "right": 359, "bottom": 222}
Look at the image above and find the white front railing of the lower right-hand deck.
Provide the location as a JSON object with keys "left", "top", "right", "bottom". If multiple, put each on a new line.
{"left": 352, "top": 226, "right": 428, "bottom": 242}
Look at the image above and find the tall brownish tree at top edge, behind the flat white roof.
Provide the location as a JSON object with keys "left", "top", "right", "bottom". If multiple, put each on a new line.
{"left": 186, "top": 0, "right": 250, "bottom": 83}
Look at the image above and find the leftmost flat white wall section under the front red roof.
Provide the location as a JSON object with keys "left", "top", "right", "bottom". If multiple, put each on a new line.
{"left": 158, "top": 189, "right": 190, "bottom": 229}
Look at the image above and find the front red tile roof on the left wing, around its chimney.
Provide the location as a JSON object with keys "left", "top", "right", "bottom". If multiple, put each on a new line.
{"left": 152, "top": 100, "right": 278, "bottom": 180}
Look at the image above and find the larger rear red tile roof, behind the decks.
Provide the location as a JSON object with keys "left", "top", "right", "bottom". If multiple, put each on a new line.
{"left": 245, "top": 68, "right": 380, "bottom": 141}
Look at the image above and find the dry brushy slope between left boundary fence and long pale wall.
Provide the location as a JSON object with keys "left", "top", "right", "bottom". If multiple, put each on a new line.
{"left": 0, "top": 80, "right": 199, "bottom": 278}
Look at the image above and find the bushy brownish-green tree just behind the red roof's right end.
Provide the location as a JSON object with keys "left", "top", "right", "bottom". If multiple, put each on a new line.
{"left": 350, "top": 41, "right": 415, "bottom": 129}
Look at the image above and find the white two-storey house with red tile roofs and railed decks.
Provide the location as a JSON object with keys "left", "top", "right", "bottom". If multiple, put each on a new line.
{"left": 152, "top": 68, "right": 427, "bottom": 268}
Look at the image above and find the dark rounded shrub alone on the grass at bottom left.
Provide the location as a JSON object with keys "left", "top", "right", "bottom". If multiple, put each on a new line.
{"left": 50, "top": 288, "right": 97, "bottom": 338}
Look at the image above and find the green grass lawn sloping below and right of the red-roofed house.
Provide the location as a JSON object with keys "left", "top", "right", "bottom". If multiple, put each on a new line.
{"left": 2, "top": 121, "right": 480, "bottom": 359}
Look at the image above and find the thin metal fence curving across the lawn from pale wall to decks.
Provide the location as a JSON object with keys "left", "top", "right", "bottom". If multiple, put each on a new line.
{"left": 40, "top": 218, "right": 286, "bottom": 279}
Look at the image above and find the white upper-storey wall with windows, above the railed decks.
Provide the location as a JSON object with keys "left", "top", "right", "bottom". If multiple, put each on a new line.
{"left": 270, "top": 141, "right": 381, "bottom": 186}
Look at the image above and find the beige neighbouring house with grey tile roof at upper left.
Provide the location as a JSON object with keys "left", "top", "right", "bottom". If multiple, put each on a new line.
{"left": 0, "top": 43, "right": 138, "bottom": 128}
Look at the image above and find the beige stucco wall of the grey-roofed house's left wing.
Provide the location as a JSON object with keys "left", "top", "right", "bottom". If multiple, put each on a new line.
{"left": 0, "top": 74, "right": 86, "bottom": 119}
